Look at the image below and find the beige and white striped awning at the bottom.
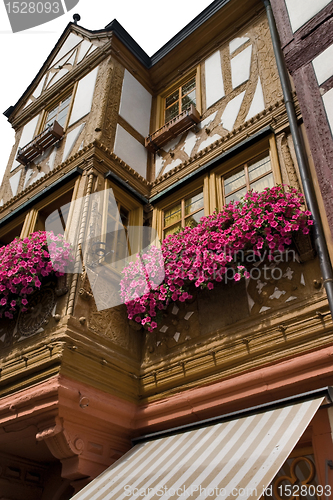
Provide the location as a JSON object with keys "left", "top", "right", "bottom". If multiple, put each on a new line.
{"left": 73, "top": 396, "right": 324, "bottom": 500}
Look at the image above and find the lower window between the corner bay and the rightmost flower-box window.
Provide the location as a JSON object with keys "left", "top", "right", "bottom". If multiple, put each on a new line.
{"left": 163, "top": 189, "right": 204, "bottom": 238}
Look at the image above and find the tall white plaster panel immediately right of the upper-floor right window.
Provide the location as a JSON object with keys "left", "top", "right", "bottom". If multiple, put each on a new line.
{"left": 205, "top": 50, "right": 225, "bottom": 108}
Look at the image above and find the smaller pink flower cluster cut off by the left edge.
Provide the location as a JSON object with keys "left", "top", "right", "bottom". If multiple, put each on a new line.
{"left": 0, "top": 231, "right": 73, "bottom": 319}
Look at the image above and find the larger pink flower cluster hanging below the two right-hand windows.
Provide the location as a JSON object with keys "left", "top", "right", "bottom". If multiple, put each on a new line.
{"left": 120, "top": 186, "right": 313, "bottom": 331}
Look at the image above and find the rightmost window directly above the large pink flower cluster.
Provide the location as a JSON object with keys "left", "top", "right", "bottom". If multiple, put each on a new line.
{"left": 222, "top": 153, "right": 274, "bottom": 204}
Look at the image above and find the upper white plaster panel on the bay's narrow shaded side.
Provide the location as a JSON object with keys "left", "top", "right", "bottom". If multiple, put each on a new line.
{"left": 119, "top": 69, "right": 152, "bottom": 137}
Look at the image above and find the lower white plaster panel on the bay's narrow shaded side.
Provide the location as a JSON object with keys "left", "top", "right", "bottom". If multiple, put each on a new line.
{"left": 114, "top": 124, "right": 147, "bottom": 177}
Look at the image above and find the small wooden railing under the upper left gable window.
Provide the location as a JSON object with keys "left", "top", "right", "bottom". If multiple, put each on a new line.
{"left": 16, "top": 121, "right": 64, "bottom": 165}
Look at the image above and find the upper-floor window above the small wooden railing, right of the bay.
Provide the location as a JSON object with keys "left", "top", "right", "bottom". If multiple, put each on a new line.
{"left": 164, "top": 75, "right": 196, "bottom": 123}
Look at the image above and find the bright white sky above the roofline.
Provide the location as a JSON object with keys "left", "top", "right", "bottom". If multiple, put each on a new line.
{"left": 0, "top": 0, "right": 212, "bottom": 186}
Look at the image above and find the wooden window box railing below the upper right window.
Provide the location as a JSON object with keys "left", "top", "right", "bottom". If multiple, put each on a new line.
{"left": 145, "top": 104, "right": 200, "bottom": 153}
